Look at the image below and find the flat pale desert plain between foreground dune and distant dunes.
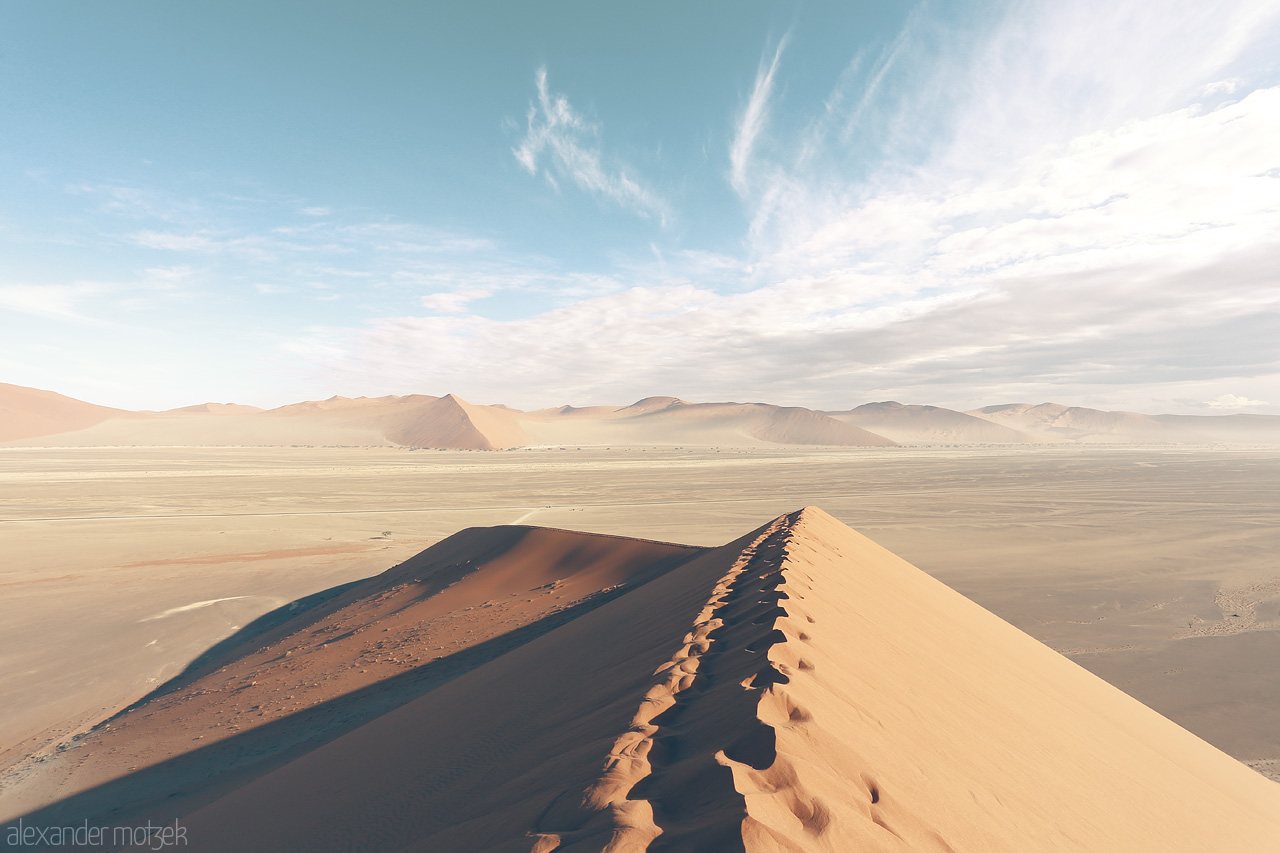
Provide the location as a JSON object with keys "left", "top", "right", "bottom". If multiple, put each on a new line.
{"left": 0, "top": 447, "right": 1280, "bottom": 794}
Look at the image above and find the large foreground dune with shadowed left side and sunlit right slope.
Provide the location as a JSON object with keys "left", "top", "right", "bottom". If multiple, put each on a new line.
{"left": 5, "top": 507, "right": 1280, "bottom": 853}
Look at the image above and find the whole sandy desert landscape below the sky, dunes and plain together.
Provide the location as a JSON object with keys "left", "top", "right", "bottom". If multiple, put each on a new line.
{"left": 0, "top": 386, "right": 1280, "bottom": 852}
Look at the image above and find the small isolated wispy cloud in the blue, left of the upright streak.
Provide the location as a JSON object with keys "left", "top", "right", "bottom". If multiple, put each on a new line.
{"left": 512, "top": 68, "right": 671, "bottom": 225}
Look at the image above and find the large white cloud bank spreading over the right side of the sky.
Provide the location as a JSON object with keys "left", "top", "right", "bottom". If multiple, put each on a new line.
{"left": 309, "top": 0, "right": 1280, "bottom": 409}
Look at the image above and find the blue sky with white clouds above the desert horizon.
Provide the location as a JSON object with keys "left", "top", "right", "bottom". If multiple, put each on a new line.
{"left": 0, "top": 0, "right": 1280, "bottom": 414}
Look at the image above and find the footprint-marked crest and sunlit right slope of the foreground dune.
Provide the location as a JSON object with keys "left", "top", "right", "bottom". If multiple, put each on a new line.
{"left": 530, "top": 507, "right": 1280, "bottom": 853}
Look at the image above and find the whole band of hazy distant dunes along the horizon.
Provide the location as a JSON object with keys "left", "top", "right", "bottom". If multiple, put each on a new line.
{"left": 0, "top": 384, "right": 1280, "bottom": 451}
